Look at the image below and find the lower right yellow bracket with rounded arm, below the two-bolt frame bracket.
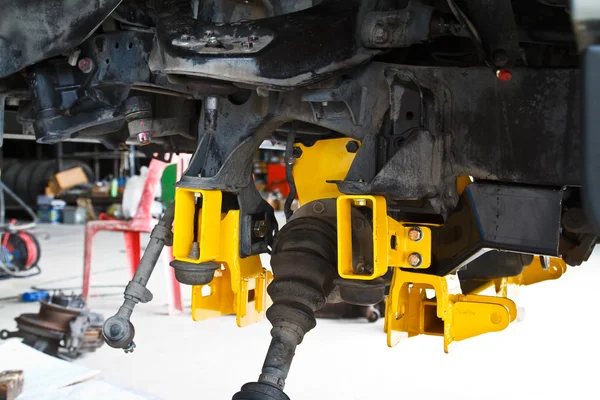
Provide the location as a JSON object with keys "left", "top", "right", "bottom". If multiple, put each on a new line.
{"left": 385, "top": 269, "right": 517, "bottom": 353}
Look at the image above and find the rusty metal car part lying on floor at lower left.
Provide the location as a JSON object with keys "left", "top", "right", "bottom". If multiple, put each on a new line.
{"left": 0, "top": 291, "right": 104, "bottom": 360}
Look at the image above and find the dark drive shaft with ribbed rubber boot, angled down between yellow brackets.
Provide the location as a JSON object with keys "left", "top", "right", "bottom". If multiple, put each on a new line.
{"left": 233, "top": 216, "right": 337, "bottom": 400}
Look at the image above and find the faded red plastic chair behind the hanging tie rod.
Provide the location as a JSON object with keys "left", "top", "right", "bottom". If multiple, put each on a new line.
{"left": 82, "top": 159, "right": 183, "bottom": 314}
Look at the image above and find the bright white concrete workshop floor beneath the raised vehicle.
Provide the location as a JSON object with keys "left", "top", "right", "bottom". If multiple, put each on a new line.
{"left": 0, "top": 226, "right": 600, "bottom": 400}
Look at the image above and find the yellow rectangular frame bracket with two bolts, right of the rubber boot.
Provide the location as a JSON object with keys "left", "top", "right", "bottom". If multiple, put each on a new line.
{"left": 336, "top": 195, "right": 431, "bottom": 280}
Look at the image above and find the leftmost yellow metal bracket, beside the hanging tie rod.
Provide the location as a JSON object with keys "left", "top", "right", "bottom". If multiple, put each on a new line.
{"left": 173, "top": 188, "right": 273, "bottom": 327}
